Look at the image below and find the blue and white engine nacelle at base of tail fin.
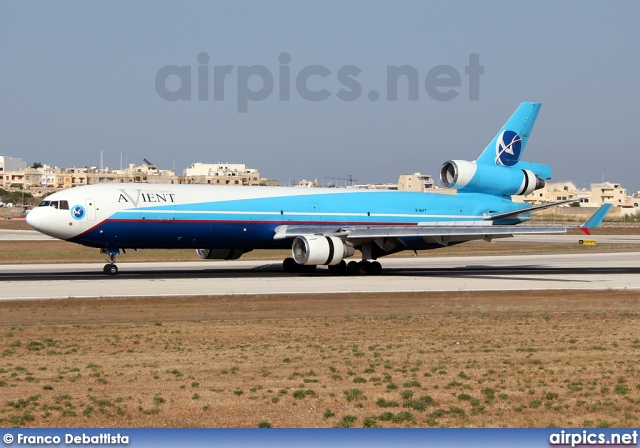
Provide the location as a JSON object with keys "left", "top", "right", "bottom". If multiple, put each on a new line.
{"left": 440, "top": 160, "right": 544, "bottom": 196}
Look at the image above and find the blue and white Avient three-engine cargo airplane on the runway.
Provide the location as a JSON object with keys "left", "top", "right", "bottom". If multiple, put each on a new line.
{"left": 27, "top": 103, "right": 611, "bottom": 275}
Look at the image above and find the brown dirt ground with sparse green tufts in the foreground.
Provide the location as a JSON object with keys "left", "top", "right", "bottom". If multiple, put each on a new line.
{"left": 0, "top": 291, "right": 640, "bottom": 427}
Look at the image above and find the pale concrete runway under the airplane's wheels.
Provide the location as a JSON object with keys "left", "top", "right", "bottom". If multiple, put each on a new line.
{"left": 0, "top": 252, "right": 640, "bottom": 300}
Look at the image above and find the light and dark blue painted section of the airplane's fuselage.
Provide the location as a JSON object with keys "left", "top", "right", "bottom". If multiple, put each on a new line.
{"left": 70, "top": 192, "right": 522, "bottom": 249}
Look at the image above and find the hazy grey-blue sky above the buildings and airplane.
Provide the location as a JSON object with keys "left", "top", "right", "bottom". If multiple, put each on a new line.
{"left": 0, "top": 0, "right": 640, "bottom": 192}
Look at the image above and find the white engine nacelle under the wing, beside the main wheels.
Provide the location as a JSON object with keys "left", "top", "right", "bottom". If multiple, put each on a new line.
{"left": 291, "top": 235, "right": 355, "bottom": 265}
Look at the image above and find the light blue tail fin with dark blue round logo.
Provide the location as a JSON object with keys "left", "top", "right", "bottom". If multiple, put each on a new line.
{"left": 476, "top": 103, "right": 542, "bottom": 166}
